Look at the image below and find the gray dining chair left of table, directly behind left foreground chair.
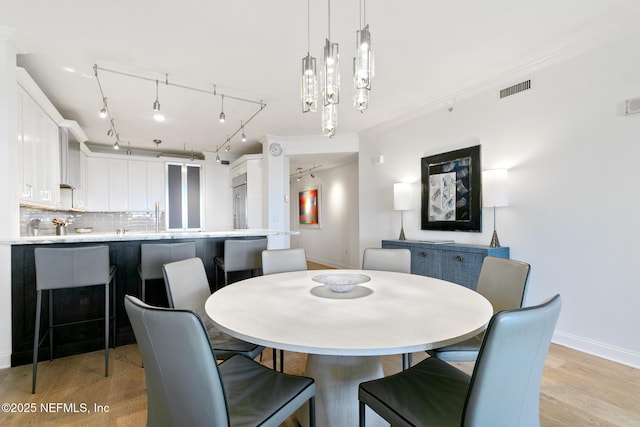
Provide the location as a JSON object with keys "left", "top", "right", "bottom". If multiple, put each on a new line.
{"left": 162, "top": 258, "right": 264, "bottom": 360}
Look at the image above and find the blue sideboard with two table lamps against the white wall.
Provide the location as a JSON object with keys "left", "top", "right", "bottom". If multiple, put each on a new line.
{"left": 382, "top": 240, "right": 509, "bottom": 290}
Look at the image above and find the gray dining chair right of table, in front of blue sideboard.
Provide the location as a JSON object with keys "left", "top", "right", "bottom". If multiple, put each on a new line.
{"left": 428, "top": 256, "right": 531, "bottom": 362}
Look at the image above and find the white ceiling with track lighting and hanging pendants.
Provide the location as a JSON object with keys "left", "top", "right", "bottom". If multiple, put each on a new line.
{"left": 0, "top": 0, "right": 640, "bottom": 170}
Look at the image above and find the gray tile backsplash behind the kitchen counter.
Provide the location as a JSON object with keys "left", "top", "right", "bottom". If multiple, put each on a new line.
{"left": 20, "top": 206, "right": 165, "bottom": 236}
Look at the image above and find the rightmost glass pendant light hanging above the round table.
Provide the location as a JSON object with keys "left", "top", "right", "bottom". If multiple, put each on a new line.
{"left": 353, "top": 0, "right": 374, "bottom": 112}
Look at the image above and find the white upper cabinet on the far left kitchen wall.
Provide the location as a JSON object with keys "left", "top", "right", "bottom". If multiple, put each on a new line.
{"left": 17, "top": 86, "right": 60, "bottom": 207}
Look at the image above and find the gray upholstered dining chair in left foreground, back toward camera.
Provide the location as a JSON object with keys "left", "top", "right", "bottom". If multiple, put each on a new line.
{"left": 124, "top": 295, "right": 315, "bottom": 427}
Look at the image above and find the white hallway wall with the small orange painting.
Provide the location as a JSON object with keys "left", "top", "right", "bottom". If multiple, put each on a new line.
{"left": 290, "top": 159, "right": 361, "bottom": 268}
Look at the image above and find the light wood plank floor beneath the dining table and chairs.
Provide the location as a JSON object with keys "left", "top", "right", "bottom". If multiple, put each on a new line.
{"left": 0, "top": 265, "right": 640, "bottom": 427}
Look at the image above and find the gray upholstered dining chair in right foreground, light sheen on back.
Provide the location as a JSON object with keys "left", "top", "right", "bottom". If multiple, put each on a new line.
{"left": 358, "top": 295, "right": 561, "bottom": 427}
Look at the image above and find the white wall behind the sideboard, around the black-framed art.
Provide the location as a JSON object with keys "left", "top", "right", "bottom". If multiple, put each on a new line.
{"left": 359, "top": 28, "right": 640, "bottom": 367}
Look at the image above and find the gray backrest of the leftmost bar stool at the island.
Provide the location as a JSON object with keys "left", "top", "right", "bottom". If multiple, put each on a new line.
{"left": 34, "top": 245, "right": 109, "bottom": 290}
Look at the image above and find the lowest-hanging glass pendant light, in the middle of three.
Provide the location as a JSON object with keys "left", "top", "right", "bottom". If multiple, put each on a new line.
{"left": 322, "top": 0, "right": 340, "bottom": 137}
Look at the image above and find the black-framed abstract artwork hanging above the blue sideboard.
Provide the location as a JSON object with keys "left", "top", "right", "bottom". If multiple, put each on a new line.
{"left": 421, "top": 145, "right": 482, "bottom": 232}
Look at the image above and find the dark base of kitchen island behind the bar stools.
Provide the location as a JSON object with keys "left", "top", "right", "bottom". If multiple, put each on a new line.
{"left": 11, "top": 238, "right": 258, "bottom": 366}
